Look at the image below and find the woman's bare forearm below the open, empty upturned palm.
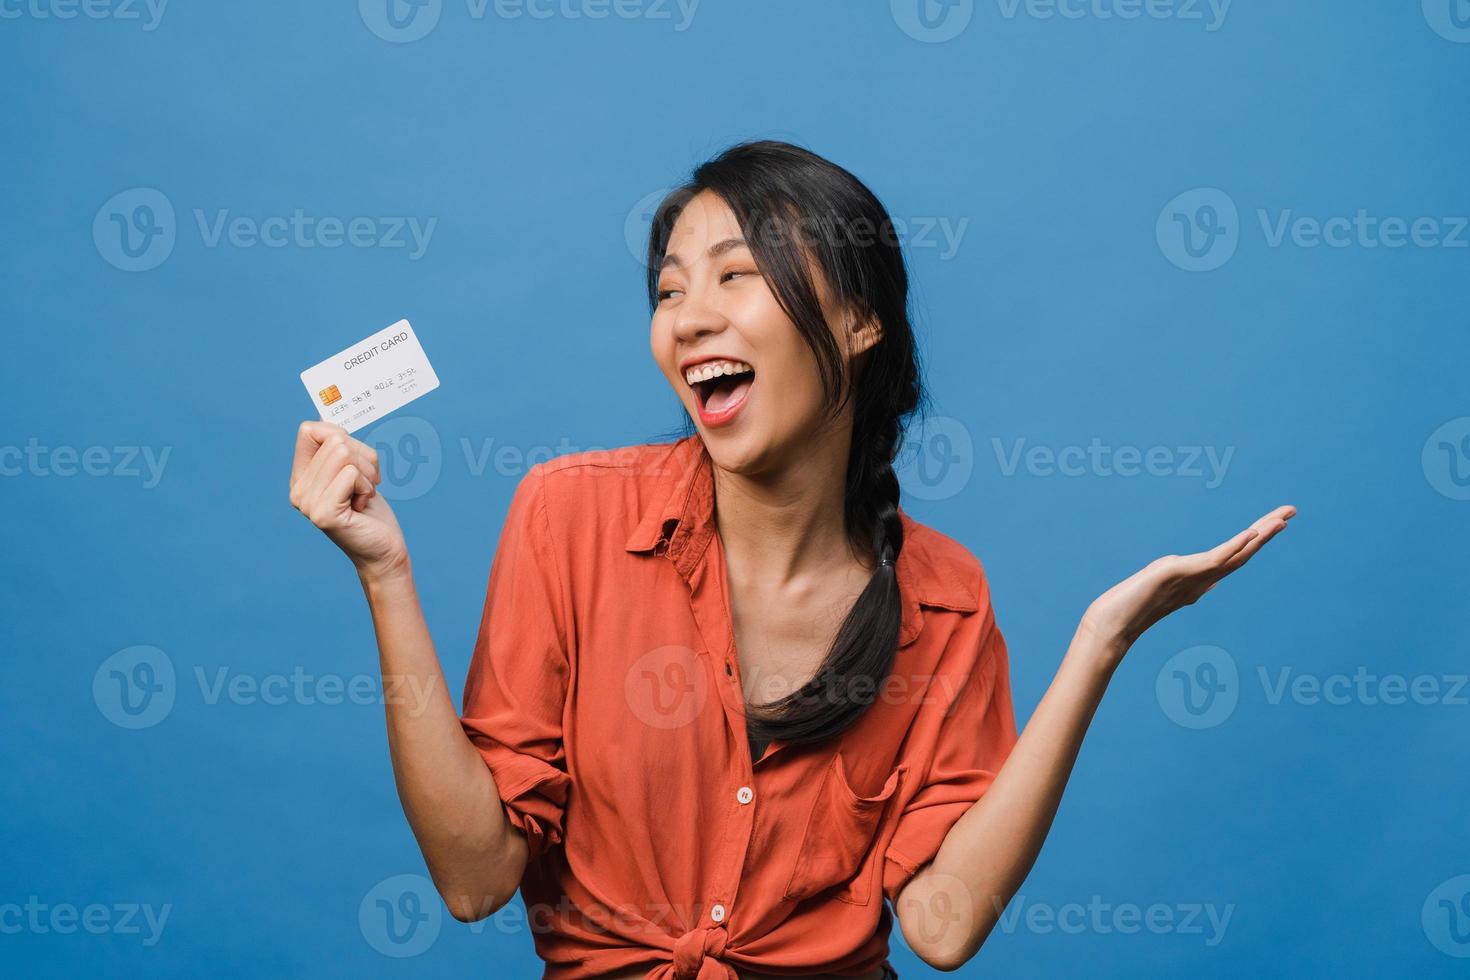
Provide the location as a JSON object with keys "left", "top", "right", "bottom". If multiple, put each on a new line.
{"left": 898, "top": 626, "right": 1122, "bottom": 970}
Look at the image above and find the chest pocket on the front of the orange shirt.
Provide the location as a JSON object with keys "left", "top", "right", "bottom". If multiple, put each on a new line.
{"left": 785, "top": 752, "right": 908, "bottom": 905}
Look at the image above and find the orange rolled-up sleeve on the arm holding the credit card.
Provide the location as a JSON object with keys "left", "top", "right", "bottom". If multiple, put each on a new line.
{"left": 460, "top": 464, "right": 572, "bottom": 858}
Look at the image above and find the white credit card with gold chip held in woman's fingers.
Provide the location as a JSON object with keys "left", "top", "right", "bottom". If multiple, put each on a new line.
{"left": 301, "top": 320, "right": 440, "bottom": 432}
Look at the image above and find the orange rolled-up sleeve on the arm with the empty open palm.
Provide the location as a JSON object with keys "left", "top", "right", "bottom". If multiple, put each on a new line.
{"left": 883, "top": 607, "right": 1017, "bottom": 905}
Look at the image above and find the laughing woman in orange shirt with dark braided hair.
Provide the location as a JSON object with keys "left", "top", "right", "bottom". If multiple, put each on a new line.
{"left": 291, "top": 141, "right": 1295, "bottom": 980}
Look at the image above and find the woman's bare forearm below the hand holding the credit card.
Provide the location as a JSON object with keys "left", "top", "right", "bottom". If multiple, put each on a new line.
{"left": 362, "top": 567, "right": 526, "bottom": 921}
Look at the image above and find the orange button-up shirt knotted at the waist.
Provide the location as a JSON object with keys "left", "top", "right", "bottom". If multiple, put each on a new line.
{"left": 460, "top": 435, "right": 1016, "bottom": 980}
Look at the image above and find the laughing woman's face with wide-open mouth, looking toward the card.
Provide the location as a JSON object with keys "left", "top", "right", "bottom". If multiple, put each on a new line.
{"left": 650, "top": 191, "right": 872, "bottom": 475}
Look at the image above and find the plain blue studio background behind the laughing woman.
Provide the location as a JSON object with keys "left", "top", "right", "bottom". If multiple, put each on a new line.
{"left": 0, "top": 0, "right": 1470, "bottom": 977}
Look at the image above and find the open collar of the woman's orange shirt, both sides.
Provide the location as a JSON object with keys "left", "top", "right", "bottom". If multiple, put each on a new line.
{"left": 626, "top": 433, "right": 979, "bottom": 646}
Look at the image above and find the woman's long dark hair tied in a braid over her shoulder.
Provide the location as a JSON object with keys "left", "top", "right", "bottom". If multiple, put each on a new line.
{"left": 648, "top": 140, "right": 925, "bottom": 742}
